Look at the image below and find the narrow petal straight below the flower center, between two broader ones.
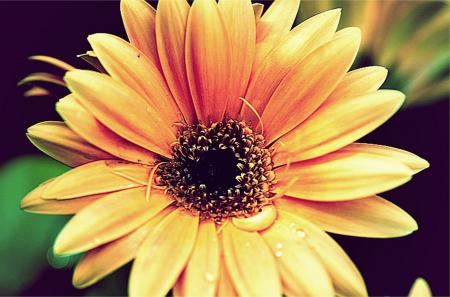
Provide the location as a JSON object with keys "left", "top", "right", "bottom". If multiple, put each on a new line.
{"left": 174, "top": 221, "right": 220, "bottom": 296}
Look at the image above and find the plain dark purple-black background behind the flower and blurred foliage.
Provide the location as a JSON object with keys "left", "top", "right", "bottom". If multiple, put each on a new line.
{"left": 0, "top": 1, "right": 449, "bottom": 296}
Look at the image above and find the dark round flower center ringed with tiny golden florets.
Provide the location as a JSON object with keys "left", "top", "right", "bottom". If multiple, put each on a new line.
{"left": 156, "top": 119, "right": 275, "bottom": 221}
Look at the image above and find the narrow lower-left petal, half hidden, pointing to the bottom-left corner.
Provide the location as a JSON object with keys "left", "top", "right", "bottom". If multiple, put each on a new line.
{"left": 72, "top": 208, "right": 170, "bottom": 288}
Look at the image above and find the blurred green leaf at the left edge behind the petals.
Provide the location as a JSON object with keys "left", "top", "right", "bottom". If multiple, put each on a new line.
{"left": 0, "top": 156, "right": 67, "bottom": 295}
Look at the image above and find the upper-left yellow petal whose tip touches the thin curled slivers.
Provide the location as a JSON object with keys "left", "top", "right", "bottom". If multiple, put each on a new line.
{"left": 64, "top": 70, "right": 176, "bottom": 157}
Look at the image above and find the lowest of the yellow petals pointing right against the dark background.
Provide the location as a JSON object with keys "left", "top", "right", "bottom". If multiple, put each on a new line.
{"left": 277, "top": 196, "right": 417, "bottom": 238}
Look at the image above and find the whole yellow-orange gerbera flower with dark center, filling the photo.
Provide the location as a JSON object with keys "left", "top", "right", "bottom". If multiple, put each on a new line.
{"left": 22, "top": 0, "right": 428, "bottom": 296}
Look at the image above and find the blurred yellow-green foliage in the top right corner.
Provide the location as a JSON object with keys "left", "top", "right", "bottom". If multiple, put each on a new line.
{"left": 298, "top": 0, "right": 450, "bottom": 106}
